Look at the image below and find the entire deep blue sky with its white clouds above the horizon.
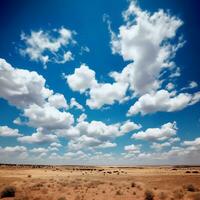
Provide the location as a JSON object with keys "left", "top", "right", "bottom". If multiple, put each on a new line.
{"left": 0, "top": 0, "right": 200, "bottom": 165}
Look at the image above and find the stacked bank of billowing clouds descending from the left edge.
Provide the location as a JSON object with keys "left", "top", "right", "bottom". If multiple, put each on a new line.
{"left": 0, "top": 59, "right": 74, "bottom": 143}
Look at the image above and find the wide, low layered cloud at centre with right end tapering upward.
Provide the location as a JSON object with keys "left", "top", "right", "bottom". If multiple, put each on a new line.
{"left": 65, "top": 121, "right": 140, "bottom": 150}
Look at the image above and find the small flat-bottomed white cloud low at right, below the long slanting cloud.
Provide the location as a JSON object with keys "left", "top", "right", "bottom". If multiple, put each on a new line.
{"left": 131, "top": 122, "right": 177, "bottom": 141}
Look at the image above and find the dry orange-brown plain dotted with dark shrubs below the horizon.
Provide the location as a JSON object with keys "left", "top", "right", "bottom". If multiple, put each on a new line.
{"left": 0, "top": 165, "right": 200, "bottom": 200}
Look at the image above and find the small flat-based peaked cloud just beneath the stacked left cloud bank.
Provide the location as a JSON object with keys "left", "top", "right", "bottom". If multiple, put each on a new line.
{"left": 17, "top": 128, "right": 57, "bottom": 143}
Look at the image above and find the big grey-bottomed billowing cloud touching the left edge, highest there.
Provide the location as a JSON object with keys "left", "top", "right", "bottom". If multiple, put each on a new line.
{"left": 0, "top": 59, "right": 52, "bottom": 108}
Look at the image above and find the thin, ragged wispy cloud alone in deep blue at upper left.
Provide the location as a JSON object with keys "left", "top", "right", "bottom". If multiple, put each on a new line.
{"left": 20, "top": 27, "right": 75, "bottom": 67}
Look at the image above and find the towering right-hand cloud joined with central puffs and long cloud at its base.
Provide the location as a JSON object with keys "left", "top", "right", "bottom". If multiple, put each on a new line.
{"left": 65, "top": 1, "right": 200, "bottom": 116}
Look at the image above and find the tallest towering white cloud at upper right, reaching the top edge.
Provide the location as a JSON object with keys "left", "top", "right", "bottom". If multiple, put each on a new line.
{"left": 111, "top": 1, "right": 183, "bottom": 95}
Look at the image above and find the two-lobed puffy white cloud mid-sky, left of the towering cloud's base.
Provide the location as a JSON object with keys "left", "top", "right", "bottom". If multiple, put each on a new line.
{"left": 65, "top": 64, "right": 128, "bottom": 109}
